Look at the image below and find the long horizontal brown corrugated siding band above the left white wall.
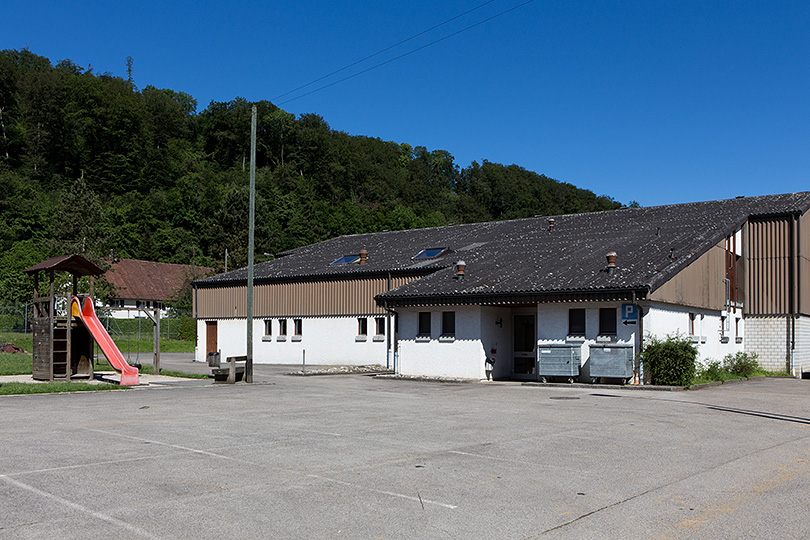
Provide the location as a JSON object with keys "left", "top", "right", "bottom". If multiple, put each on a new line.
{"left": 197, "top": 276, "right": 418, "bottom": 319}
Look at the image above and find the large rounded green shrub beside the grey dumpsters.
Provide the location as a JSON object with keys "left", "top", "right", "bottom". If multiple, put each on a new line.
{"left": 641, "top": 334, "right": 697, "bottom": 386}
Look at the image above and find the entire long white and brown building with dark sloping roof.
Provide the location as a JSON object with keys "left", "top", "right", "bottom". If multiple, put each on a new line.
{"left": 195, "top": 192, "right": 810, "bottom": 384}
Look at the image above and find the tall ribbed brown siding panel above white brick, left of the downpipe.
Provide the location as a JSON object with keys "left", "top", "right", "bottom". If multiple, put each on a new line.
{"left": 745, "top": 217, "right": 792, "bottom": 315}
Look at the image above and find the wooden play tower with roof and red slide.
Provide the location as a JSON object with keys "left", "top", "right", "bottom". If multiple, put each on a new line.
{"left": 24, "top": 255, "right": 140, "bottom": 385}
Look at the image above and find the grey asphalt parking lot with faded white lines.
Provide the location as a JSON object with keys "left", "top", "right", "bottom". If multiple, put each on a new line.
{"left": 0, "top": 368, "right": 810, "bottom": 539}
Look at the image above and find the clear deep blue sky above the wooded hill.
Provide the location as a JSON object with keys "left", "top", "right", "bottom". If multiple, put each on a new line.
{"left": 0, "top": 0, "right": 810, "bottom": 206}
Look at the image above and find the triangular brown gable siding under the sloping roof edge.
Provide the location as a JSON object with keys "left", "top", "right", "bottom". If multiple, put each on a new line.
{"left": 649, "top": 240, "right": 726, "bottom": 310}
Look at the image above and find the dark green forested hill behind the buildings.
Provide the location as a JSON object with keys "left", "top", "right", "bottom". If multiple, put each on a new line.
{"left": 0, "top": 50, "right": 620, "bottom": 302}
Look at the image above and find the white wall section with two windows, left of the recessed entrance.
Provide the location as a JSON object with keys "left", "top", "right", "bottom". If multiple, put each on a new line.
{"left": 397, "top": 306, "right": 482, "bottom": 379}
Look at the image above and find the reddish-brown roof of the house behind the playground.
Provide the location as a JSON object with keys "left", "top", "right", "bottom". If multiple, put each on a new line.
{"left": 104, "top": 259, "right": 214, "bottom": 302}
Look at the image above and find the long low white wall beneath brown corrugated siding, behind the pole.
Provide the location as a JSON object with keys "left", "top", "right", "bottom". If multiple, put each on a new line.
{"left": 195, "top": 316, "right": 387, "bottom": 366}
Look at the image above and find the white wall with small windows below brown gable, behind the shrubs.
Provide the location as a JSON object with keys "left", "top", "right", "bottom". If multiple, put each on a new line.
{"left": 644, "top": 303, "right": 745, "bottom": 365}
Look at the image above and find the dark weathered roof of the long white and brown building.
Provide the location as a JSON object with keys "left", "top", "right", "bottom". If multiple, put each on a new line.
{"left": 196, "top": 192, "right": 810, "bottom": 299}
